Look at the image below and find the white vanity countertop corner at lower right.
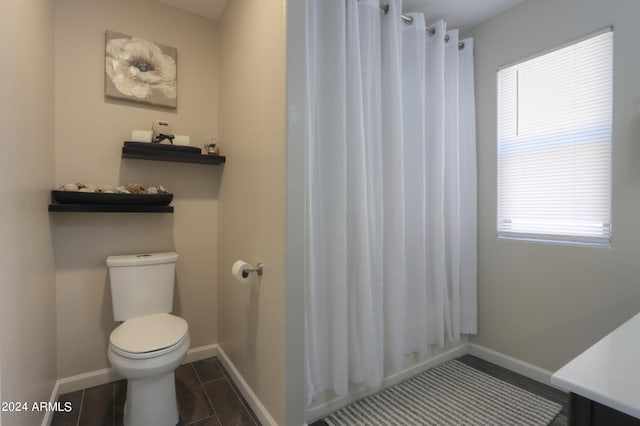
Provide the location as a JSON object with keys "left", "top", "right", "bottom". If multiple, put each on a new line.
{"left": 551, "top": 313, "right": 640, "bottom": 418}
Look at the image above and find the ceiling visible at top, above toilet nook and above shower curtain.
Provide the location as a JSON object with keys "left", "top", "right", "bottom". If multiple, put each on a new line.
{"left": 156, "top": 0, "right": 523, "bottom": 30}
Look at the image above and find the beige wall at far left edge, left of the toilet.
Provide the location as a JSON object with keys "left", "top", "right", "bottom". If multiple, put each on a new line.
{"left": 0, "top": 0, "right": 56, "bottom": 425}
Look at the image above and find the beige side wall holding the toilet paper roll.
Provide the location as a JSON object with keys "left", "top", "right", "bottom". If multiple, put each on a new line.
{"left": 218, "top": 0, "right": 288, "bottom": 425}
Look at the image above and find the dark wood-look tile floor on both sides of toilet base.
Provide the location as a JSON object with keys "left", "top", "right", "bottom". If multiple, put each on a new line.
{"left": 51, "top": 357, "right": 260, "bottom": 426}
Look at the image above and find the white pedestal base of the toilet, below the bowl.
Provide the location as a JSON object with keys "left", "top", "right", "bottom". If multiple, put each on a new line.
{"left": 124, "top": 371, "right": 178, "bottom": 426}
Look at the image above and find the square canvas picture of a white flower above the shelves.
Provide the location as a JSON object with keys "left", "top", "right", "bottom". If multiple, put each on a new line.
{"left": 104, "top": 31, "right": 178, "bottom": 108}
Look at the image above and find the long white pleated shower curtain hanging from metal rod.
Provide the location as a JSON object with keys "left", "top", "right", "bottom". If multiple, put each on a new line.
{"left": 305, "top": 0, "right": 476, "bottom": 404}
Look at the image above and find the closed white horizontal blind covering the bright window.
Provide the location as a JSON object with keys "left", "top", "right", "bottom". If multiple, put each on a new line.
{"left": 497, "top": 31, "right": 613, "bottom": 245}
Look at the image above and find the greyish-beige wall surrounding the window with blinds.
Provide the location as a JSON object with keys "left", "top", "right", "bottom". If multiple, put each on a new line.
{"left": 468, "top": 0, "right": 640, "bottom": 370}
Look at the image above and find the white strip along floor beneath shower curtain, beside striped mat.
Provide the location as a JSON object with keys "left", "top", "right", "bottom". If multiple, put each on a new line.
{"left": 305, "top": 342, "right": 467, "bottom": 424}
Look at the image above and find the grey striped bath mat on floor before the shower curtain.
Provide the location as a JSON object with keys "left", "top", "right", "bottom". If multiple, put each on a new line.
{"left": 324, "top": 360, "right": 562, "bottom": 426}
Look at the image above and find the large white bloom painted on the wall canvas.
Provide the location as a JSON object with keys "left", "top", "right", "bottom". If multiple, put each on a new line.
{"left": 106, "top": 38, "right": 176, "bottom": 99}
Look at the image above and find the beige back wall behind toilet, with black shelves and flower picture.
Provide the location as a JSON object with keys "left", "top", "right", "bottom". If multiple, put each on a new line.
{"left": 51, "top": 0, "right": 224, "bottom": 378}
